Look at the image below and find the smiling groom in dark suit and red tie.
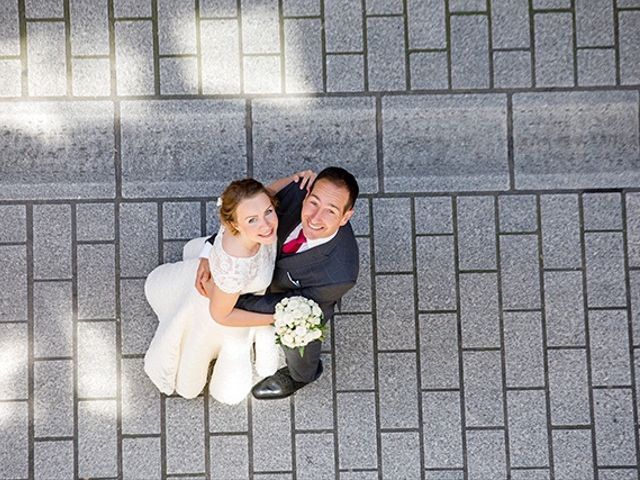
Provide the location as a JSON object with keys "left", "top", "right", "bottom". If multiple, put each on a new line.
{"left": 196, "top": 167, "right": 359, "bottom": 399}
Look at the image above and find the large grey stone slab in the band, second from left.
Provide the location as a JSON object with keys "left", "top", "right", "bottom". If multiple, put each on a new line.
{"left": 121, "top": 100, "right": 248, "bottom": 197}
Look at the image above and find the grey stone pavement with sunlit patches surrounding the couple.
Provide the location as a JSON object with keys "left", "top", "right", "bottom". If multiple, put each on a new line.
{"left": 0, "top": 0, "right": 640, "bottom": 480}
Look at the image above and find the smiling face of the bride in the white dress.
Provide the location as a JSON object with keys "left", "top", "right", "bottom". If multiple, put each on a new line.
{"left": 234, "top": 193, "right": 278, "bottom": 245}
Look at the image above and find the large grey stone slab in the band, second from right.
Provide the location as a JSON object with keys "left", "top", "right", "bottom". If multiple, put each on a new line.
{"left": 382, "top": 95, "right": 509, "bottom": 192}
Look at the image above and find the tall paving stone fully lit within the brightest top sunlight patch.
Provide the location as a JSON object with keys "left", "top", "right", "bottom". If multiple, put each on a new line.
{"left": 200, "top": 19, "right": 240, "bottom": 94}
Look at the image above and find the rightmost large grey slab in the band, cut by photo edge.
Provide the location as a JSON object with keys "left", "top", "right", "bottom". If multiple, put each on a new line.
{"left": 513, "top": 91, "right": 640, "bottom": 188}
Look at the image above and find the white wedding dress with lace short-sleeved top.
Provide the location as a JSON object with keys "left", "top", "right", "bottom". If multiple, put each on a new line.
{"left": 144, "top": 227, "right": 280, "bottom": 404}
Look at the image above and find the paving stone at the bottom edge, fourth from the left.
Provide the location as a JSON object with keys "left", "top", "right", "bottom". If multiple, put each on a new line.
{"left": 122, "top": 437, "right": 161, "bottom": 478}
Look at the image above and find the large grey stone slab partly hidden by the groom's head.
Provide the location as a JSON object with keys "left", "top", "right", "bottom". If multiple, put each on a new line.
{"left": 252, "top": 98, "right": 378, "bottom": 192}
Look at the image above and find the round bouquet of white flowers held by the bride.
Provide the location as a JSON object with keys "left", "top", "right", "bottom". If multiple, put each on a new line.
{"left": 273, "top": 297, "right": 326, "bottom": 356}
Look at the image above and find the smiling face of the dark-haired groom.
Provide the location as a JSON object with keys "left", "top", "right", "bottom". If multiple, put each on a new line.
{"left": 300, "top": 179, "right": 353, "bottom": 240}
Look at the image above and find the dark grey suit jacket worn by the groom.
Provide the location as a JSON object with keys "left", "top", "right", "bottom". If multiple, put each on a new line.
{"left": 209, "top": 182, "right": 359, "bottom": 321}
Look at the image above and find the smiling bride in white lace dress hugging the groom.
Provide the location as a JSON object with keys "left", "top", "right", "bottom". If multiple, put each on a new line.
{"left": 144, "top": 170, "right": 315, "bottom": 404}
